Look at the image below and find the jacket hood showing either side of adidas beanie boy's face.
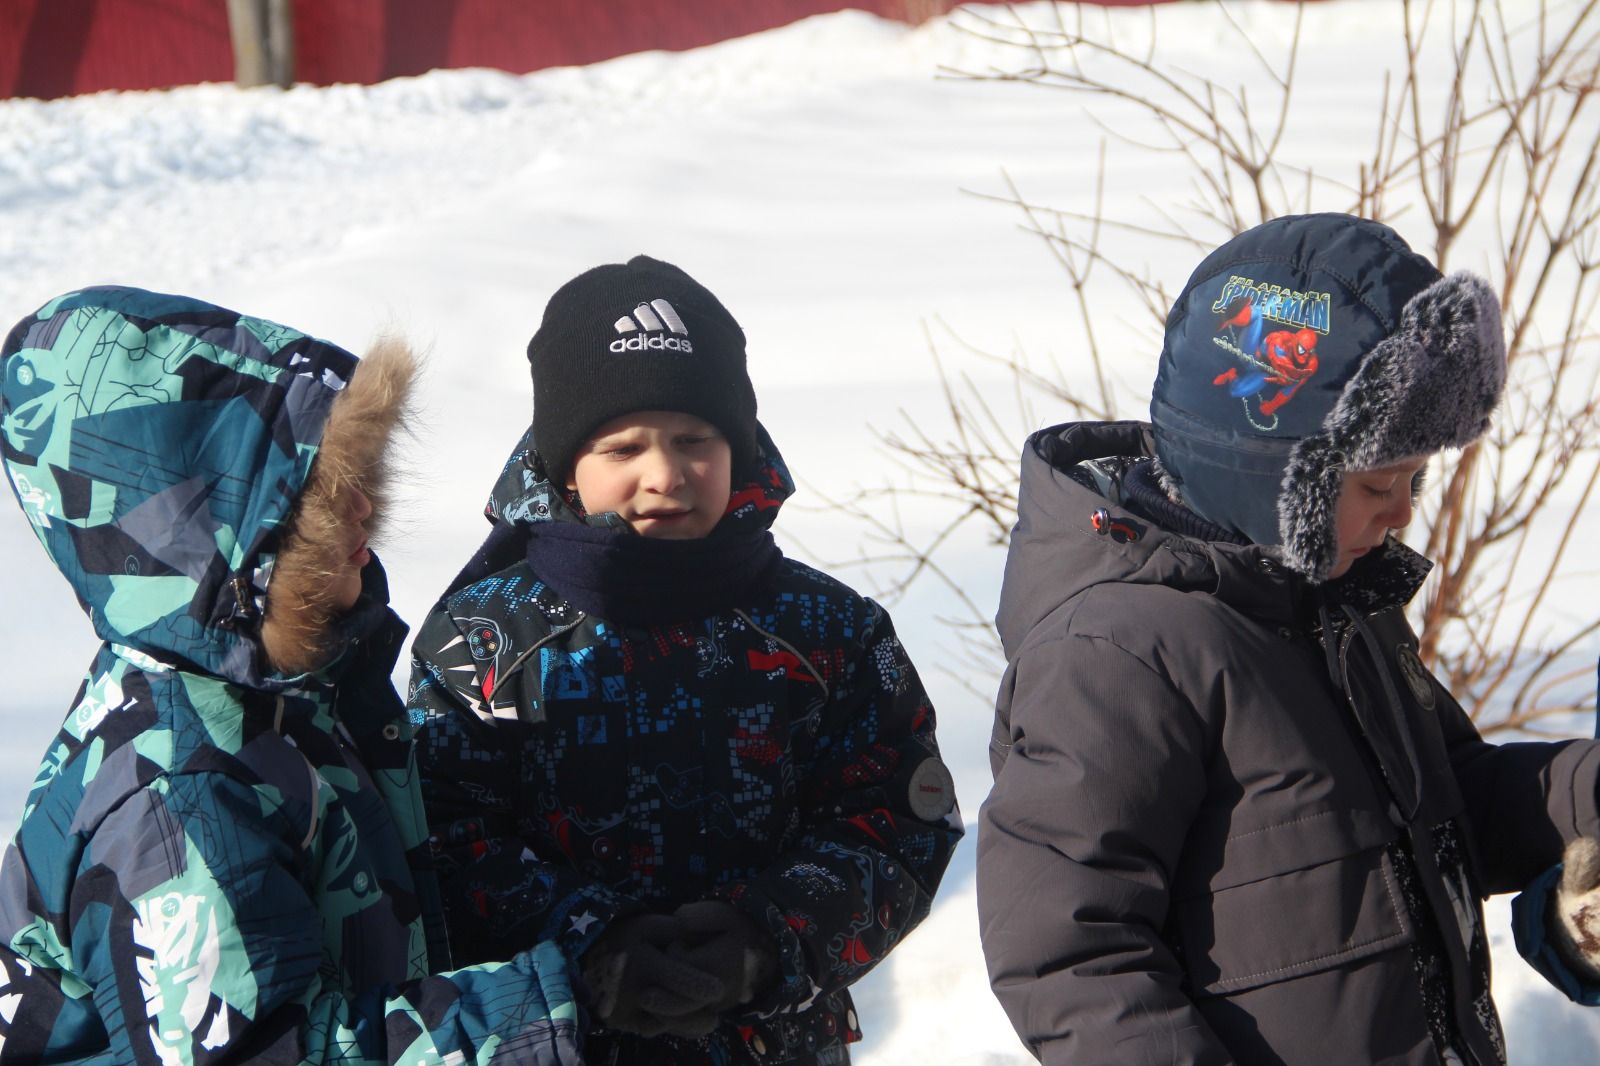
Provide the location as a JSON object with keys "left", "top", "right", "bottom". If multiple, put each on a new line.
{"left": 483, "top": 423, "right": 795, "bottom": 530}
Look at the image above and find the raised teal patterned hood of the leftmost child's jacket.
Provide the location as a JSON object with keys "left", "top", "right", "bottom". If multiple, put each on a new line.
{"left": 0, "top": 287, "right": 412, "bottom": 688}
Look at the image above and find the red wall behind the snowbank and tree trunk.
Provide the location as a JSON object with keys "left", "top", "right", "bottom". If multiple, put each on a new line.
{"left": 0, "top": 0, "right": 1160, "bottom": 98}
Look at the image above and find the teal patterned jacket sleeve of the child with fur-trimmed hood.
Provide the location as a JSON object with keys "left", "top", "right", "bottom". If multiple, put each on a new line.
{"left": 70, "top": 771, "right": 579, "bottom": 1066}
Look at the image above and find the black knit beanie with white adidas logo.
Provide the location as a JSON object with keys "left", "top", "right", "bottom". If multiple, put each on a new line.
{"left": 528, "top": 256, "right": 757, "bottom": 483}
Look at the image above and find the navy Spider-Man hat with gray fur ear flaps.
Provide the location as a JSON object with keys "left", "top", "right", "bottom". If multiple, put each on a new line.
{"left": 1150, "top": 214, "right": 1506, "bottom": 581}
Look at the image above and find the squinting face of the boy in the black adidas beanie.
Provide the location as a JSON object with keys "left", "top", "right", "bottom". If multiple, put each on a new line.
{"left": 566, "top": 411, "right": 733, "bottom": 539}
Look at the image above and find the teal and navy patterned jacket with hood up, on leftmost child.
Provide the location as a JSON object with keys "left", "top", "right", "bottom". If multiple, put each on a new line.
{"left": 0, "top": 288, "right": 579, "bottom": 1066}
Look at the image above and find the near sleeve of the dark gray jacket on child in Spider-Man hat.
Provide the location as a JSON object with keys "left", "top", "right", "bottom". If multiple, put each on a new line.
{"left": 978, "top": 635, "right": 1234, "bottom": 1066}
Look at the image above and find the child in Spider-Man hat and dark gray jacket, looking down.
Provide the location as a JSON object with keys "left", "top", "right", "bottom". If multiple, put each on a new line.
{"left": 978, "top": 214, "right": 1600, "bottom": 1066}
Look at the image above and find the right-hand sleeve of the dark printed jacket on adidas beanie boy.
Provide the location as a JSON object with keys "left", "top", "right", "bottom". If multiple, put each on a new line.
{"left": 717, "top": 599, "right": 962, "bottom": 1013}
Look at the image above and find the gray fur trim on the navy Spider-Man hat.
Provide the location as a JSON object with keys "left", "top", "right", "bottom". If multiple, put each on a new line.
{"left": 1278, "top": 272, "right": 1506, "bottom": 581}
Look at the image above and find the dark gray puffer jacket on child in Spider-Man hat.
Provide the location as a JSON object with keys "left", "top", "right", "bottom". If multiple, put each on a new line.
{"left": 978, "top": 423, "right": 1600, "bottom": 1066}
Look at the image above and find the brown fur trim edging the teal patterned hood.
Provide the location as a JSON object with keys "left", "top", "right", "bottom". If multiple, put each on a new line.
{"left": 261, "top": 336, "right": 418, "bottom": 675}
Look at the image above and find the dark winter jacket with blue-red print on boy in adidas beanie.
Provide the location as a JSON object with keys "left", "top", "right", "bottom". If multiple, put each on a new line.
{"left": 410, "top": 431, "right": 962, "bottom": 1066}
